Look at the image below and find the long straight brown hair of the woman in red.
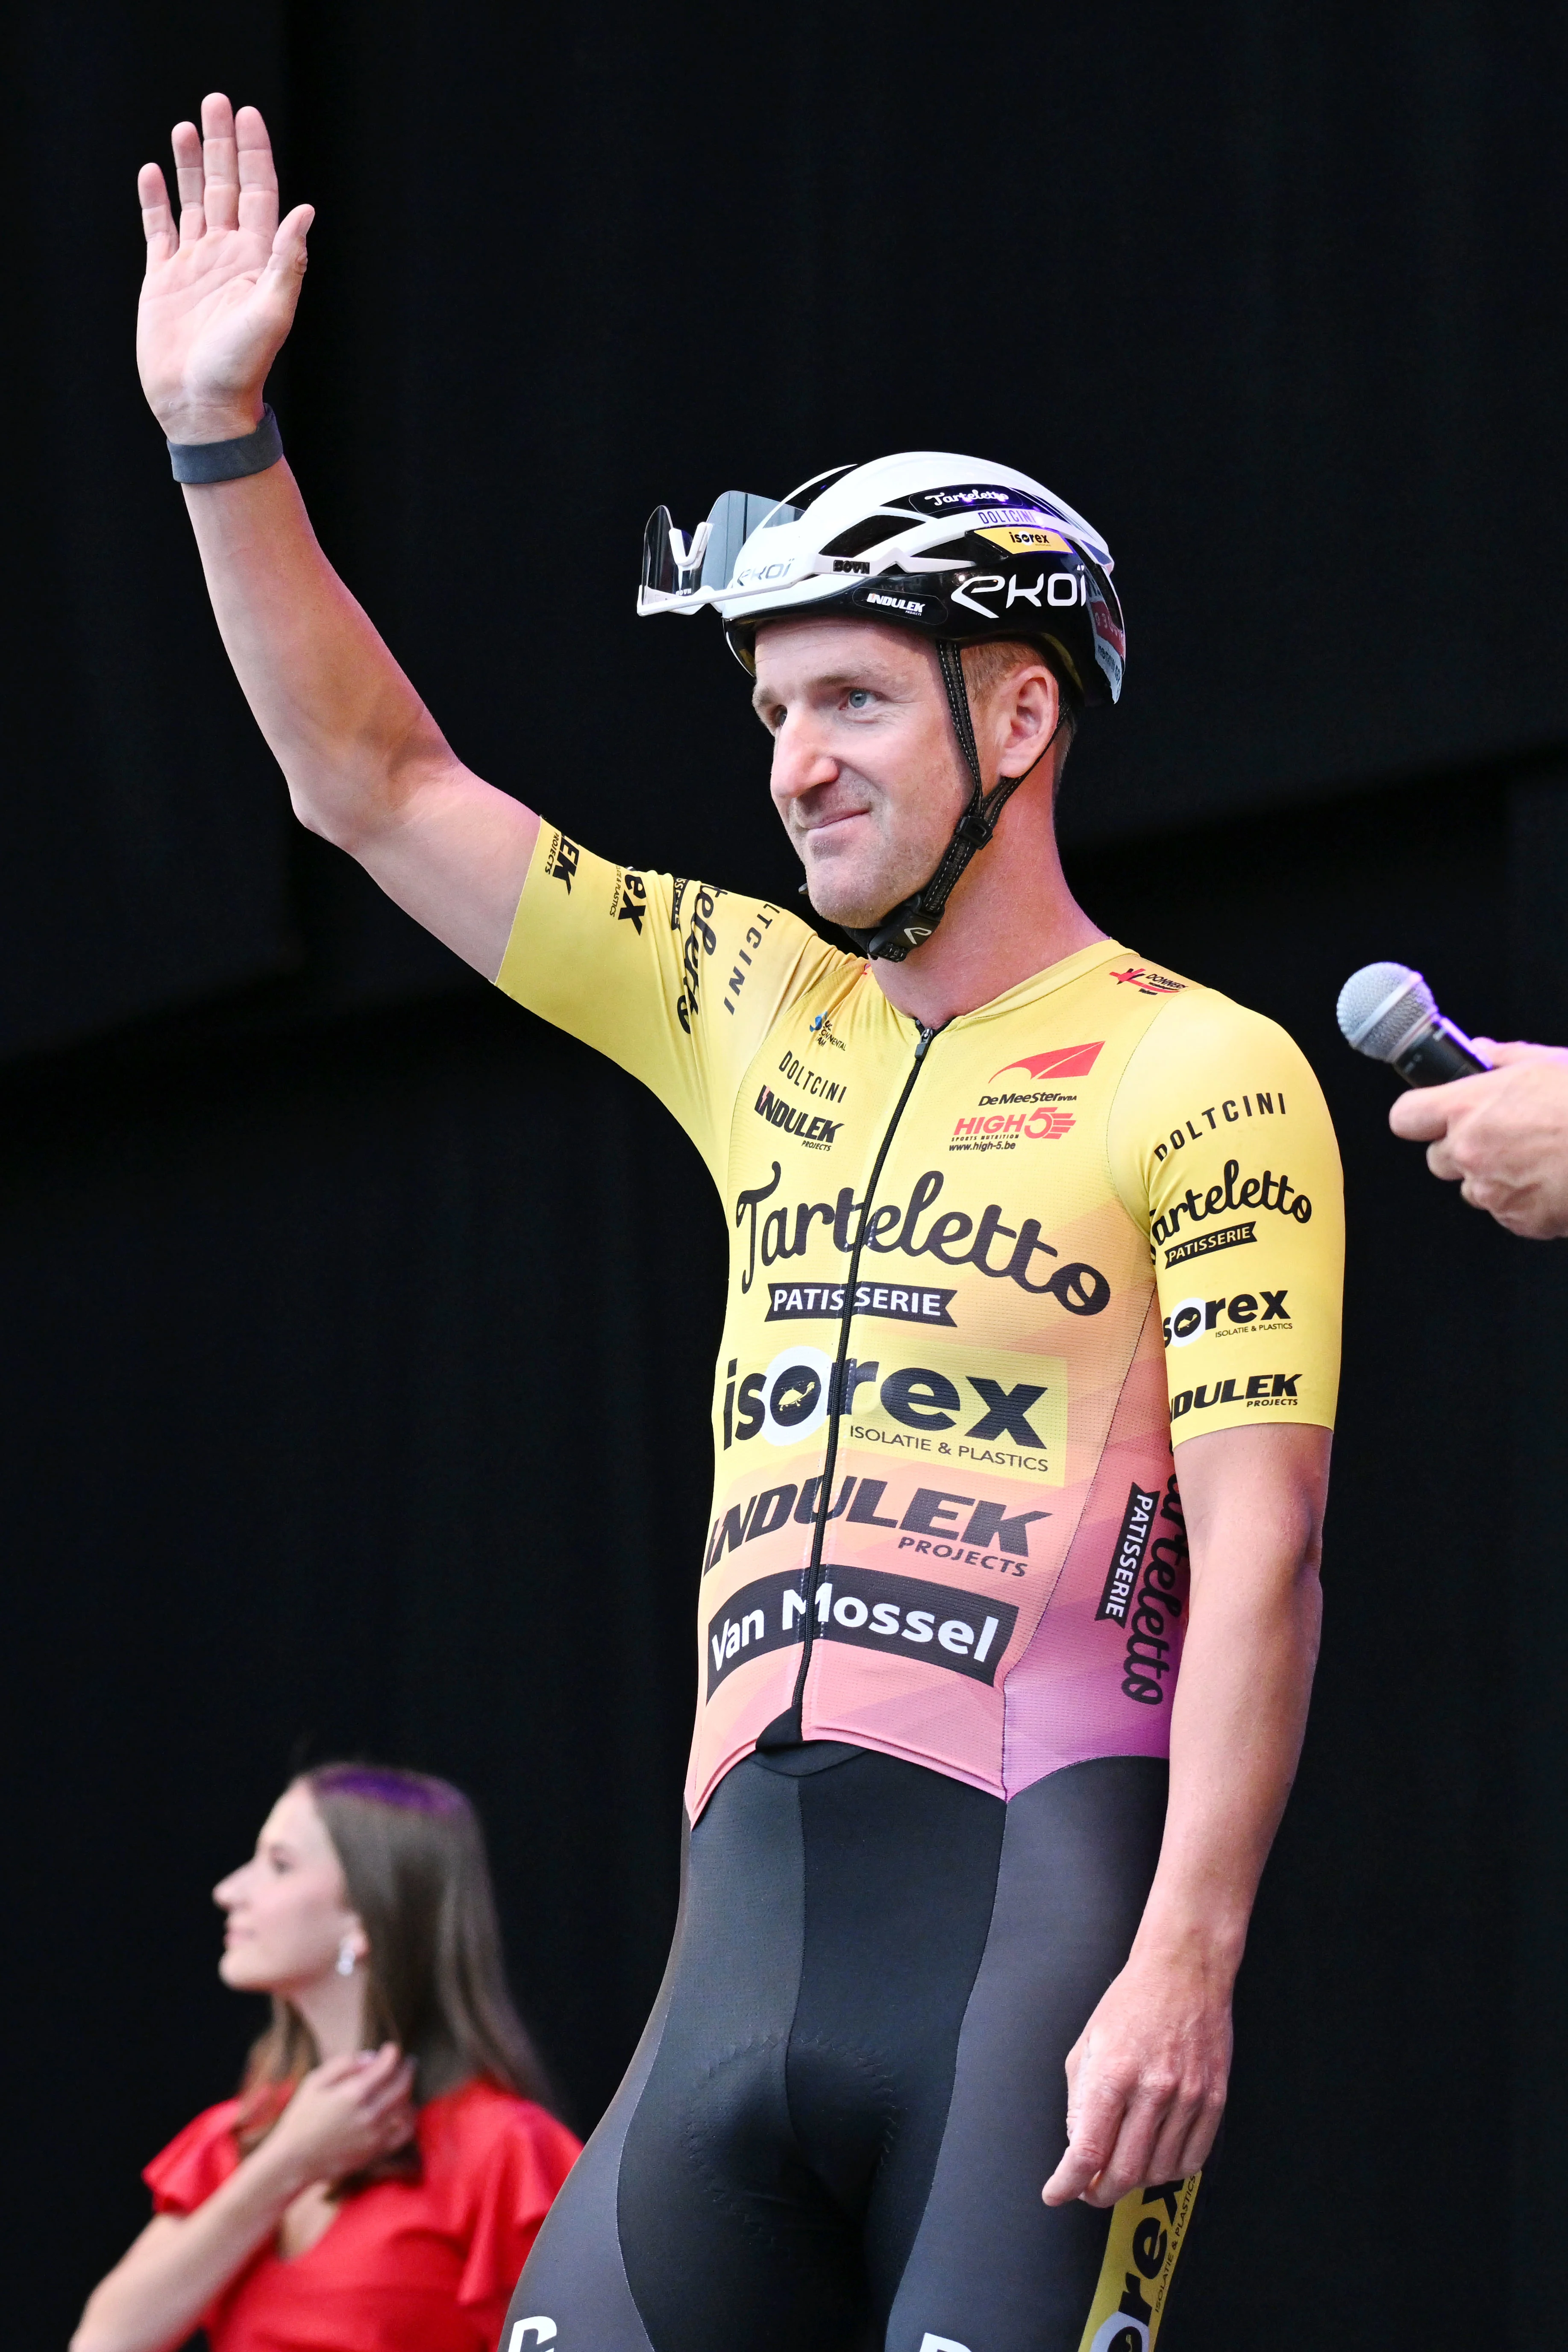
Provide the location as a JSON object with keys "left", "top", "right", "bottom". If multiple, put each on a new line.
{"left": 235, "top": 1764, "right": 550, "bottom": 2187}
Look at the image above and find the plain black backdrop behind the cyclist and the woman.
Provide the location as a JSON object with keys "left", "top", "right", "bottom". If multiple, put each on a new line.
{"left": 0, "top": 0, "right": 1568, "bottom": 2352}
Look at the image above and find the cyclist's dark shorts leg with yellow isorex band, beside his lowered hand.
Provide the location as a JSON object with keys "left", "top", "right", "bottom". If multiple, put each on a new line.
{"left": 886, "top": 1757, "right": 1192, "bottom": 2352}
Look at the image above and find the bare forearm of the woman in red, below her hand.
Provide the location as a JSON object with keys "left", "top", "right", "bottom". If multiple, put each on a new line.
{"left": 70, "top": 2143, "right": 303, "bottom": 2352}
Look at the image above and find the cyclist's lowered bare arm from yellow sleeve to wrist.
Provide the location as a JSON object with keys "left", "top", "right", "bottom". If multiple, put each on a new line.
{"left": 1138, "top": 1467, "right": 1321, "bottom": 1983}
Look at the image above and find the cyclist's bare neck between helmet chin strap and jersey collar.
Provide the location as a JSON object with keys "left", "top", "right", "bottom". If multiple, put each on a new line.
{"left": 872, "top": 776, "right": 1107, "bottom": 1028}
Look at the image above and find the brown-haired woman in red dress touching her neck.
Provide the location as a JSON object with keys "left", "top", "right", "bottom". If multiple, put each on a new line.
{"left": 70, "top": 1764, "right": 578, "bottom": 2352}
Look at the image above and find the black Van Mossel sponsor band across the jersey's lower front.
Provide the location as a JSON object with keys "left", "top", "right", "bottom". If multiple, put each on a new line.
{"left": 705, "top": 1567, "right": 1018, "bottom": 1698}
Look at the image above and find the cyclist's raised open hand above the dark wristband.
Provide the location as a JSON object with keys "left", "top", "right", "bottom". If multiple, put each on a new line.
{"left": 136, "top": 94, "right": 315, "bottom": 442}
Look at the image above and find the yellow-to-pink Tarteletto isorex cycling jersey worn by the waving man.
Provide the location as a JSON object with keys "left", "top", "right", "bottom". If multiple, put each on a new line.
{"left": 498, "top": 826, "right": 1345, "bottom": 1820}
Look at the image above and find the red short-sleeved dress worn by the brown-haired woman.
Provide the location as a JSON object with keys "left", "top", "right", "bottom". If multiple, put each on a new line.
{"left": 141, "top": 2082, "right": 578, "bottom": 2352}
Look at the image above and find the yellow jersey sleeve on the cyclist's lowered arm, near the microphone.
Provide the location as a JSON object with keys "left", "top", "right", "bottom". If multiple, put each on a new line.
{"left": 1110, "top": 990, "right": 1345, "bottom": 1446}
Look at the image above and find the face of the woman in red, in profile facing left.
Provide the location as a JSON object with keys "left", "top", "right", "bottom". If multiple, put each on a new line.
{"left": 211, "top": 1781, "right": 367, "bottom": 1994}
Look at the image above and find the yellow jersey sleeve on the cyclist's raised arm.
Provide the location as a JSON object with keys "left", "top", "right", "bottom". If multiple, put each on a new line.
{"left": 496, "top": 826, "right": 853, "bottom": 1181}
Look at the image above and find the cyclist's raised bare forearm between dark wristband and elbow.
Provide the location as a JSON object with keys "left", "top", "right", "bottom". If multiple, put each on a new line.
{"left": 186, "top": 461, "right": 456, "bottom": 849}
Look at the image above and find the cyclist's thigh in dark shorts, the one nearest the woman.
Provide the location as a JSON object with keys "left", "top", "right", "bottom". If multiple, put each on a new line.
{"left": 503, "top": 1767, "right": 875, "bottom": 2352}
